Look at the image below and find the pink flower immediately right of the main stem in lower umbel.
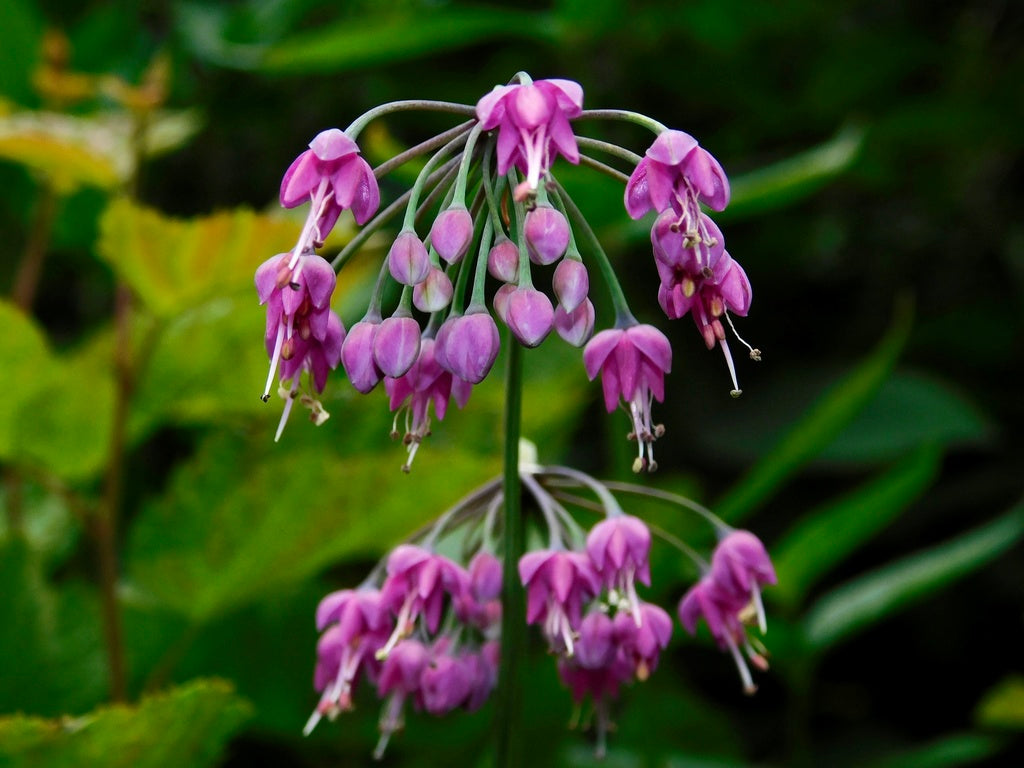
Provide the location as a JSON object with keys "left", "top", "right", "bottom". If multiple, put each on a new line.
{"left": 519, "top": 550, "right": 601, "bottom": 656}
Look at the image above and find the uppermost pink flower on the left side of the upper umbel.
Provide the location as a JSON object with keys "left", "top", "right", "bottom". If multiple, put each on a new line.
{"left": 281, "top": 128, "right": 381, "bottom": 282}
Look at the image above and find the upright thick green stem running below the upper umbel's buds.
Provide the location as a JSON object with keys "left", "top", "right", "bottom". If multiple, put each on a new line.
{"left": 495, "top": 333, "right": 526, "bottom": 768}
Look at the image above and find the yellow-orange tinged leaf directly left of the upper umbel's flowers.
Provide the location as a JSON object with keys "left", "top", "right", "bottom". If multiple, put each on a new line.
{"left": 97, "top": 199, "right": 298, "bottom": 319}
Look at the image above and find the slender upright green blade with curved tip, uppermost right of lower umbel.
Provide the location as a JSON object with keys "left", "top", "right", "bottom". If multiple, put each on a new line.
{"left": 715, "top": 305, "right": 910, "bottom": 522}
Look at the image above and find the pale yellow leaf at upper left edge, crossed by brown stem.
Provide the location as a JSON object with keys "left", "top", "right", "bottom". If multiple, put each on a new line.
{"left": 0, "top": 111, "right": 201, "bottom": 194}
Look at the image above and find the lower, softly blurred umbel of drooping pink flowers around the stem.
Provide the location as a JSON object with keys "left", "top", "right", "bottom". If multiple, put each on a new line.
{"left": 305, "top": 465, "right": 775, "bottom": 758}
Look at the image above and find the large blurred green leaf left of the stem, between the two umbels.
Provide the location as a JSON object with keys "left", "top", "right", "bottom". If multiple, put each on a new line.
{"left": 126, "top": 434, "right": 497, "bottom": 624}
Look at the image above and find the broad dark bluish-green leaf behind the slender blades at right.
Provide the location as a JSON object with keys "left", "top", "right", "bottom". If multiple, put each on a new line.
{"left": 817, "top": 372, "right": 991, "bottom": 462}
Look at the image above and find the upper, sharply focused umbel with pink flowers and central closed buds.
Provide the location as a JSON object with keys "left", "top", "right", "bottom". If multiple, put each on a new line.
{"left": 256, "top": 73, "right": 760, "bottom": 472}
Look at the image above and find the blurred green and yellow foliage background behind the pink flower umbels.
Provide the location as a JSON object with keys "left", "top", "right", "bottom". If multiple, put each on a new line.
{"left": 0, "top": 0, "right": 1024, "bottom": 768}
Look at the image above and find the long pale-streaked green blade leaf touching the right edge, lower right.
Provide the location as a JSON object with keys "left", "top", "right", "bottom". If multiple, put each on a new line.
{"left": 804, "top": 504, "right": 1024, "bottom": 651}
